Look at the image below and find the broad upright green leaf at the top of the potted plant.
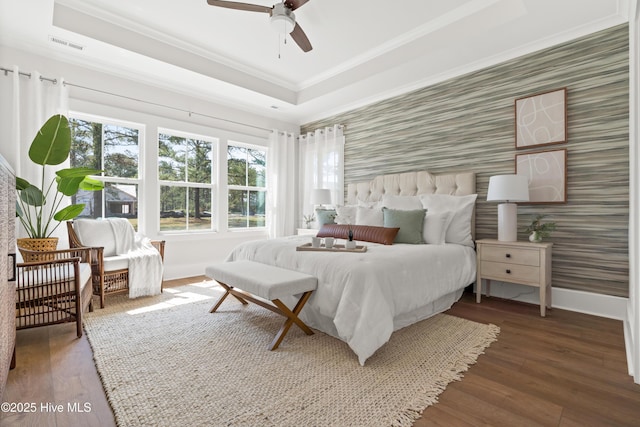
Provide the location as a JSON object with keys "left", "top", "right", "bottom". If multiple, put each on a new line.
{"left": 29, "top": 114, "right": 71, "bottom": 165}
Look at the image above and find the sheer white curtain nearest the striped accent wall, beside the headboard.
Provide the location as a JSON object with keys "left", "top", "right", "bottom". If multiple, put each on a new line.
{"left": 299, "top": 125, "right": 344, "bottom": 220}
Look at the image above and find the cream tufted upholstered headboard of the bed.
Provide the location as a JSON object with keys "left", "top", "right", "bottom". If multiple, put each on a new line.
{"left": 346, "top": 171, "right": 476, "bottom": 236}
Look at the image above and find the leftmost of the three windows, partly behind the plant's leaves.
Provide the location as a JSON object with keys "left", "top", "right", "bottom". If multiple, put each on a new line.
{"left": 69, "top": 116, "right": 142, "bottom": 229}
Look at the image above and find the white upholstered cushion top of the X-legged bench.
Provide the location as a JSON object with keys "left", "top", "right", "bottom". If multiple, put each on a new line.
{"left": 205, "top": 261, "right": 318, "bottom": 301}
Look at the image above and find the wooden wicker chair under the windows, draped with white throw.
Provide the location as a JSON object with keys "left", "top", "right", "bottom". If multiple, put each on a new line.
{"left": 67, "top": 221, "right": 165, "bottom": 308}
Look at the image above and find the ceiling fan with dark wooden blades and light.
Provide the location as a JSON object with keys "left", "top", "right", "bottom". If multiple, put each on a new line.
{"left": 207, "top": 0, "right": 312, "bottom": 52}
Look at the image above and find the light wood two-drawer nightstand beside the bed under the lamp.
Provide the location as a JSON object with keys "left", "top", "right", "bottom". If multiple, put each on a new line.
{"left": 476, "top": 239, "right": 553, "bottom": 317}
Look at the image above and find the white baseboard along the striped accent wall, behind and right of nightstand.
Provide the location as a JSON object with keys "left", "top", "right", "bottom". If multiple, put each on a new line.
{"left": 472, "top": 280, "right": 629, "bottom": 321}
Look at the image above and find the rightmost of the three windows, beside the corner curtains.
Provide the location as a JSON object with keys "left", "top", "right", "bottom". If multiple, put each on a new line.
{"left": 227, "top": 142, "right": 267, "bottom": 229}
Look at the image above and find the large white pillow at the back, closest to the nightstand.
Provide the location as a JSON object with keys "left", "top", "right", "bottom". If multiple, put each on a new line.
{"left": 420, "top": 194, "right": 478, "bottom": 247}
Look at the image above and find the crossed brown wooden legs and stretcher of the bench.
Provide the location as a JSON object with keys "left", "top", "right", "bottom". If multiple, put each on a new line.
{"left": 209, "top": 281, "right": 313, "bottom": 350}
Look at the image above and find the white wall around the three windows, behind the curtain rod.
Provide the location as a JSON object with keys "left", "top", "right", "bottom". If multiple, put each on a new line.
{"left": 0, "top": 47, "right": 299, "bottom": 279}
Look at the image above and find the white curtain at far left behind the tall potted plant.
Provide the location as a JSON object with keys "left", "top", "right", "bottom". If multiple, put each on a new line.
{"left": 0, "top": 66, "right": 69, "bottom": 242}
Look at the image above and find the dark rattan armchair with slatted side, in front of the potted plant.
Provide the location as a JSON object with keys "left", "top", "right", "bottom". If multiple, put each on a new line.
{"left": 16, "top": 248, "right": 93, "bottom": 338}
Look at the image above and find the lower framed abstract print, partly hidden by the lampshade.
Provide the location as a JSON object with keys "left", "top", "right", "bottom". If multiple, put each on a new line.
{"left": 516, "top": 148, "right": 567, "bottom": 204}
